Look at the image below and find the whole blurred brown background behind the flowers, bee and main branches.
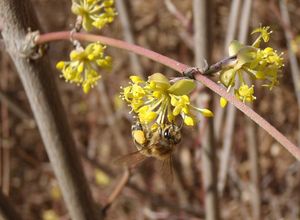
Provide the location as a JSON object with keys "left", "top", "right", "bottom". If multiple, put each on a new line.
{"left": 0, "top": 0, "right": 300, "bottom": 220}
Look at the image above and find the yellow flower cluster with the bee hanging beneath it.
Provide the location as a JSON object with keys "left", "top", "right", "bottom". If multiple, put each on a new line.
{"left": 121, "top": 73, "right": 213, "bottom": 126}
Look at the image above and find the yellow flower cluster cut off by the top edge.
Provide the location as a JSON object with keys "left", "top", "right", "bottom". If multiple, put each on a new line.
{"left": 72, "top": 0, "right": 117, "bottom": 31}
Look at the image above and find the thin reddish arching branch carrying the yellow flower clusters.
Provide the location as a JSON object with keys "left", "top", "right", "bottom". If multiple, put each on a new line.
{"left": 36, "top": 31, "right": 300, "bottom": 160}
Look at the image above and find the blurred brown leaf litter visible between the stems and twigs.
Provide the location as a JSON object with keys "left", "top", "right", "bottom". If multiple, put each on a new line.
{"left": 0, "top": 0, "right": 300, "bottom": 220}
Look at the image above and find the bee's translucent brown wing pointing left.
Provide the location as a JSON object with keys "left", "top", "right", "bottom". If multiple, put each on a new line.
{"left": 115, "top": 150, "right": 148, "bottom": 168}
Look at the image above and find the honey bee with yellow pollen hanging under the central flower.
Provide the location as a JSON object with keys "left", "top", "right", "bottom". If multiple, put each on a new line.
{"left": 119, "top": 121, "right": 181, "bottom": 180}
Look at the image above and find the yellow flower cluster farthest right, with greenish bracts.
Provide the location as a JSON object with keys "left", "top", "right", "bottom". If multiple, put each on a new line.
{"left": 219, "top": 27, "right": 284, "bottom": 107}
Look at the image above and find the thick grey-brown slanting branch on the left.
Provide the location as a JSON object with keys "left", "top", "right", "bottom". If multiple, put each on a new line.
{"left": 0, "top": 0, "right": 100, "bottom": 220}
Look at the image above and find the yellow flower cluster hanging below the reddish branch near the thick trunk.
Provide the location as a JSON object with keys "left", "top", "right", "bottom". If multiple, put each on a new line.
{"left": 56, "top": 43, "right": 111, "bottom": 93}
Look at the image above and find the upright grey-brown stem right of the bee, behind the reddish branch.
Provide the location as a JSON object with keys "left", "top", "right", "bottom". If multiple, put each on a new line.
{"left": 193, "top": 0, "right": 220, "bottom": 220}
